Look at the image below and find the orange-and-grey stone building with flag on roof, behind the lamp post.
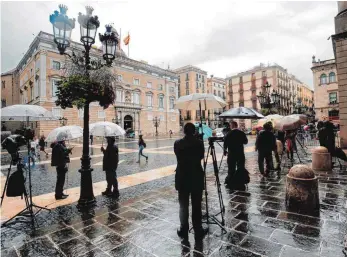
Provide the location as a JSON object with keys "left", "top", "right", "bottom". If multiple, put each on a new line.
{"left": 1, "top": 31, "right": 179, "bottom": 136}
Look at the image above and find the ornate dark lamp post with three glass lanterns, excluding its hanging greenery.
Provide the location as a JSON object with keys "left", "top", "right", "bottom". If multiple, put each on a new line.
{"left": 49, "top": 5, "right": 118, "bottom": 207}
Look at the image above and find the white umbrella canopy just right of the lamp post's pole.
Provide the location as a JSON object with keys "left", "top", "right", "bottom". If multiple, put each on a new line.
{"left": 89, "top": 121, "right": 125, "bottom": 137}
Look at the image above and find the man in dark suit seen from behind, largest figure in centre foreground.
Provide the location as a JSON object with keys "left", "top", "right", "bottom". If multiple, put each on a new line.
{"left": 174, "top": 123, "right": 207, "bottom": 239}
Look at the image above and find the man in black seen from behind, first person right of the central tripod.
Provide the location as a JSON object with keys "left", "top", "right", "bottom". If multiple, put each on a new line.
{"left": 224, "top": 121, "right": 248, "bottom": 185}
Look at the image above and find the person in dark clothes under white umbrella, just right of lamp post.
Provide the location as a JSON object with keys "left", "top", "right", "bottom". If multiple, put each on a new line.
{"left": 101, "top": 137, "right": 119, "bottom": 198}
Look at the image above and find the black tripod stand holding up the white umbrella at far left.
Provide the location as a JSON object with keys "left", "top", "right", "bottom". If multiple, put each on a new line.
{"left": 1, "top": 139, "right": 51, "bottom": 227}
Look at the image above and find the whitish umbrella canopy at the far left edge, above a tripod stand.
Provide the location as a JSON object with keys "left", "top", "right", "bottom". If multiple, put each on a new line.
{"left": 0, "top": 104, "right": 58, "bottom": 121}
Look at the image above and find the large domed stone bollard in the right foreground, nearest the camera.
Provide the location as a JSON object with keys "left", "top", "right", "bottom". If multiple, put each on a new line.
{"left": 286, "top": 164, "right": 319, "bottom": 213}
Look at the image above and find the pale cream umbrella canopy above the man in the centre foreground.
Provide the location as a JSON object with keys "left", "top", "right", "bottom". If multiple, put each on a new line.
{"left": 175, "top": 93, "right": 227, "bottom": 110}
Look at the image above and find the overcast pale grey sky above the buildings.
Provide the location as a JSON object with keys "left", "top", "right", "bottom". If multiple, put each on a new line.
{"left": 1, "top": 0, "right": 337, "bottom": 86}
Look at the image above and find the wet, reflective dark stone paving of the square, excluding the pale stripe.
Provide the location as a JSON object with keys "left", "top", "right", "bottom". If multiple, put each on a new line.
{"left": 1, "top": 135, "right": 347, "bottom": 257}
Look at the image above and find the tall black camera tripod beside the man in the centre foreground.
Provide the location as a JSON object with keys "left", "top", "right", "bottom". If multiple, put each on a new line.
{"left": 203, "top": 137, "right": 227, "bottom": 234}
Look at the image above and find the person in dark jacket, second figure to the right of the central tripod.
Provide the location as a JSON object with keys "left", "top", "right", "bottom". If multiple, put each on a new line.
{"left": 255, "top": 122, "right": 277, "bottom": 176}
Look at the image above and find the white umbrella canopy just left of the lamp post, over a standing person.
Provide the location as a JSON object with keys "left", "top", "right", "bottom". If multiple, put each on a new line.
{"left": 46, "top": 126, "right": 83, "bottom": 142}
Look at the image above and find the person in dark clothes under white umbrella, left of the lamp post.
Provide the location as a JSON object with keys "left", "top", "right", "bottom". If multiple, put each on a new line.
{"left": 51, "top": 140, "right": 71, "bottom": 200}
